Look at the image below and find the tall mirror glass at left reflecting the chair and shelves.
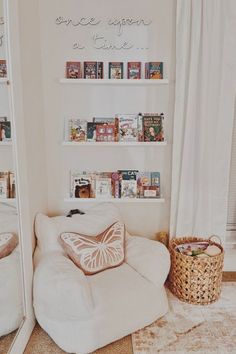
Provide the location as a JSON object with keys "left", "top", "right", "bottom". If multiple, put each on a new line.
{"left": 0, "top": 0, "right": 24, "bottom": 353}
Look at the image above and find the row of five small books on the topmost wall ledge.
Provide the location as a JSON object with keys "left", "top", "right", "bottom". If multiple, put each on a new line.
{"left": 66, "top": 61, "right": 163, "bottom": 80}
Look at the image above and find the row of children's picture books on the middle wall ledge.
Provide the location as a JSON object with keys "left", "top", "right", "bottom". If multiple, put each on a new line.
{"left": 65, "top": 113, "right": 164, "bottom": 143}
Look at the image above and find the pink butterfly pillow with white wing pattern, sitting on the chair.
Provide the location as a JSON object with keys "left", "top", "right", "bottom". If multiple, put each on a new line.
{"left": 60, "top": 222, "right": 125, "bottom": 275}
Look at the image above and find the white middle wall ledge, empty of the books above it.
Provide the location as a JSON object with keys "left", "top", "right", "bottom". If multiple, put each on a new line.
{"left": 62, "top": 141, "right": 167, "bottom": 147}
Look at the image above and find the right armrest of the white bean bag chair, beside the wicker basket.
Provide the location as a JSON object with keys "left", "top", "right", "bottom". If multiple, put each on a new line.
{"left": 125, "top": 235, "right": 170, "bottom": 287}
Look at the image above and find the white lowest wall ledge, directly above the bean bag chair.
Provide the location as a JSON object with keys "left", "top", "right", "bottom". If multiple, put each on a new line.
{"left": 64, "top": 198, "right": 165, "bottom": 204}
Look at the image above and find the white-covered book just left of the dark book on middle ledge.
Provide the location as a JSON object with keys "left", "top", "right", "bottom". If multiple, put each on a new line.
{"left": 116, "top": 114, "right": 138, "bottom": 142}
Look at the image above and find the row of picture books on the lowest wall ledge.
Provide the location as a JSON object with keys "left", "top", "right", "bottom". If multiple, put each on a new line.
{"left": 70, "top": 170, "right": 160, "bottom": 199}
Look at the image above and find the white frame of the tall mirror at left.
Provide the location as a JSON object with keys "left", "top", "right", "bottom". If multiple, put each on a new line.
{"left": 3, "top": 0, "right": 35, "bottom": 354}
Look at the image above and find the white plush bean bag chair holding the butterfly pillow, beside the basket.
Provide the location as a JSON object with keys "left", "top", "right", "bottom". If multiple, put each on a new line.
{"left": 33, "top": 203, "right": 170, "bottom": 354}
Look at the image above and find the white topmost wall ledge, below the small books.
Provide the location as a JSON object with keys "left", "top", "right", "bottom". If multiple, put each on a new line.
{"left": 60, "top": 79, "right": 169, "bottom": 86}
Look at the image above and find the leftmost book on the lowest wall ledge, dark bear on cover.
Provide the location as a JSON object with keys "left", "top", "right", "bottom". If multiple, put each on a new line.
{"left": 71, "top": 172, "right": 92, "bottom": 198}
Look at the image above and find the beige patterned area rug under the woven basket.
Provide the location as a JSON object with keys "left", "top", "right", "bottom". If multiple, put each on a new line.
{"left": 132, "top": 282, "right": 236, "bottom": 354}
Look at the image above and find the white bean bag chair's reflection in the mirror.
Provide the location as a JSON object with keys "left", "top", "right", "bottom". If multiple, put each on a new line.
{"left": 0, "top": 203, "right": 23, "bottom": 337}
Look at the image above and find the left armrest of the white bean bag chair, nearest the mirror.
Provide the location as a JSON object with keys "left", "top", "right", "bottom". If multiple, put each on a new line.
{"left": 33, "top": 252, "right": 93, "bottom": 320}
